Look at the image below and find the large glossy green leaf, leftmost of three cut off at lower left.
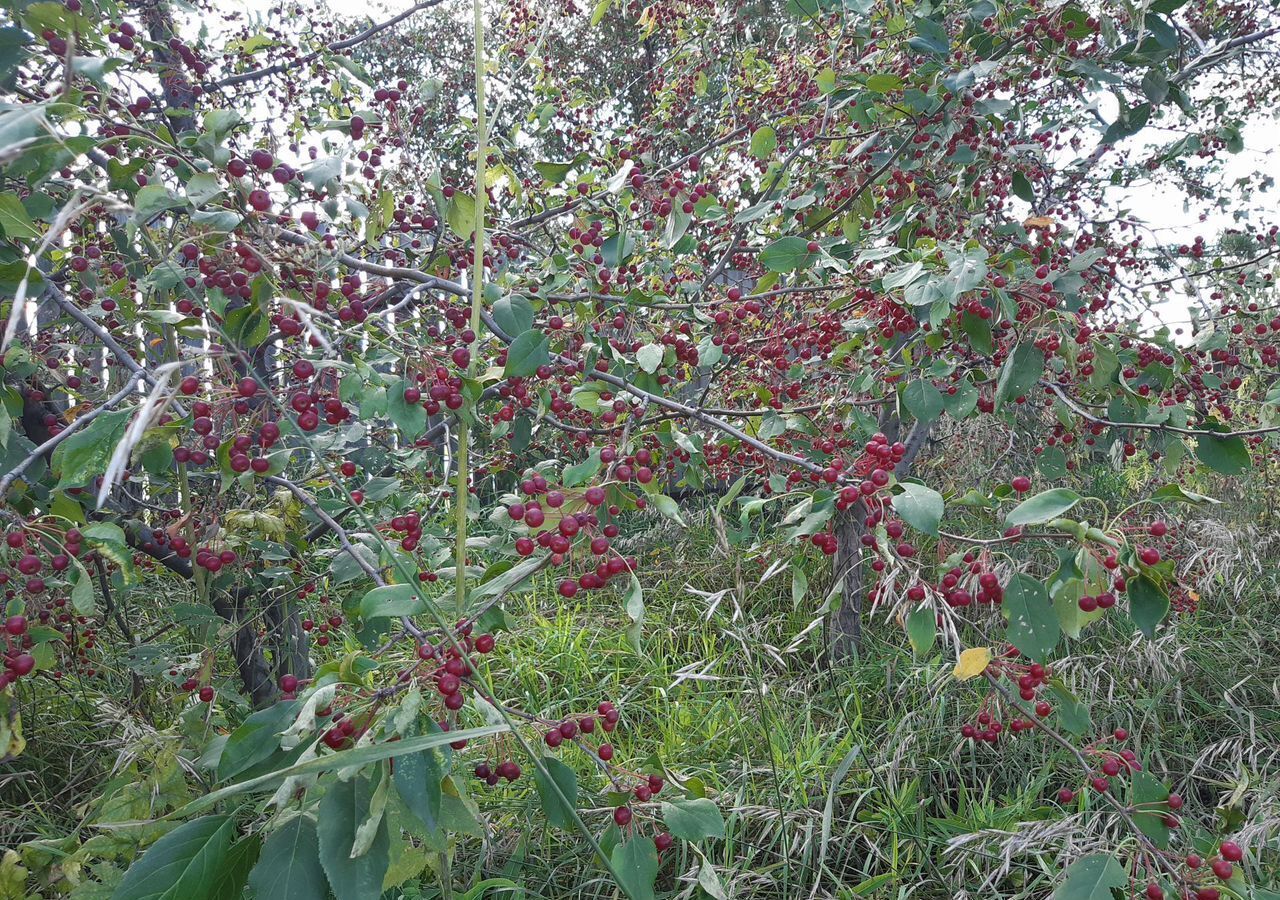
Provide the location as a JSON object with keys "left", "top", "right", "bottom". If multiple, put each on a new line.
{"left": 111, "top": 816, "right": 236, "bottom": 900}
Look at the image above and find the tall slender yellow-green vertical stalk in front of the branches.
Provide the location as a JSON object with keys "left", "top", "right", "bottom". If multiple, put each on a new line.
{"left": 453, "top": 0, "right": 488, "bottom": 618}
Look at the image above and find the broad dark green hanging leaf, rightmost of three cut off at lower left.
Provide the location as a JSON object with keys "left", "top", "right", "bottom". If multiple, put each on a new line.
{"left": 316, "top": 776, "right": 390, "bottom": 900}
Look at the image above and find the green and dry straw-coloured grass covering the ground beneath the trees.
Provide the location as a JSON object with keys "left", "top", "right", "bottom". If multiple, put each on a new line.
{"left": 0, "top": 476, "right": 1280, "bottom": 900}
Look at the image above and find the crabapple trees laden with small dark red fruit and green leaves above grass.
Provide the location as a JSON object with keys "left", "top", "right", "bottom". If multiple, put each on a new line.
{"left": 0, "top": 0, "right": 1280, "bottom": 900}
